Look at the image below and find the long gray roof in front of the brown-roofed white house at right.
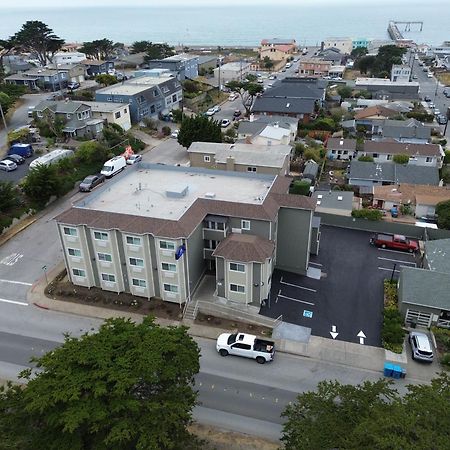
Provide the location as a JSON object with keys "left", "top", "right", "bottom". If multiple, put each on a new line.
{"left": 348, "top": 160, "right": 439, "bottom": 186}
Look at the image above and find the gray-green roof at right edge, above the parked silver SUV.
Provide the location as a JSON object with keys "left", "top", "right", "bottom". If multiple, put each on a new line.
{"left": 399, "top": 267, "right": 450, "bottom": 310}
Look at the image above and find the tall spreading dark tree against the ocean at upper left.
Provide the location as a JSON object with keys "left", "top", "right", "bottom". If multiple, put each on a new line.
{"left": 11, "top": 20, "right": 64, "bottom": 66}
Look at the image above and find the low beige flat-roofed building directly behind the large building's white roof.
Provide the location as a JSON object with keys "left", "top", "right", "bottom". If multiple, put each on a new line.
{"left": 188, "top": 142, "right": 292, "bottom": 175}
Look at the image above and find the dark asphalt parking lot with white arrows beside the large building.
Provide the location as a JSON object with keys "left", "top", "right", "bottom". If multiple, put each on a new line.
{"left": 261, "top": 226, "right": 417, "bottom": 346}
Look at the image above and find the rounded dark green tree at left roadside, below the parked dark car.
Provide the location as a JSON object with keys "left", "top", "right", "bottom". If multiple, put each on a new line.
{"left": 22, "top": 164, "right": 62, "bottom": 207}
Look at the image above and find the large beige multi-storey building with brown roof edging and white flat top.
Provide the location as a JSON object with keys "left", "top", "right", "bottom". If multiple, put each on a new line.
{"left": 56, "top": 162, "right": 320, "bottom": 309}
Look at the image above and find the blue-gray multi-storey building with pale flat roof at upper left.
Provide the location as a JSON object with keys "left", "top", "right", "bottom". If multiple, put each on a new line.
{"left": 95, "top": 76, "right": 183, "bottom": 123}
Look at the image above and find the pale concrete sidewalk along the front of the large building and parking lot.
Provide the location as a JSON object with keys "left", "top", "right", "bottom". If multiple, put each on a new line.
{"left": 27, "top": 262, "right": 434, "bottom": 382}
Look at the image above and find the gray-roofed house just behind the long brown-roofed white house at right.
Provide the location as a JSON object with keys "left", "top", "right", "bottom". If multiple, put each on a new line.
{"left": 372, "top": 118, "right": 432, "bottom": 144}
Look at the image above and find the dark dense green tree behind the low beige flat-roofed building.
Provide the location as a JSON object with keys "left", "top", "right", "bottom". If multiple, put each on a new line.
{"left": 178, "top": 115, "right": 222, "bottom": 148}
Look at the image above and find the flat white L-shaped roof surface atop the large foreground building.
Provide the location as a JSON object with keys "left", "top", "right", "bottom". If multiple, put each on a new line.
{"left": 76, "top": 163, "right": 275, "bottom": 220}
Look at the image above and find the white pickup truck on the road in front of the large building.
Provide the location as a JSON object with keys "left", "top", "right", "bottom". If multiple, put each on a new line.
{"left": 216, "top": 333, "right": 275, "bottom": 364}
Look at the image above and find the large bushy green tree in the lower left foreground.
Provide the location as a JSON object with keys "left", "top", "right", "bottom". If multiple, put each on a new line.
{"left": 0, "top": 317, "right": 200, "bottom": 450}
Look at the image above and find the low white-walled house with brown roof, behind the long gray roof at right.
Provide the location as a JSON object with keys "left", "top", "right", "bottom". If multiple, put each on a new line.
{"left": 357, "top": 141, "right": 445, "bottom": 168}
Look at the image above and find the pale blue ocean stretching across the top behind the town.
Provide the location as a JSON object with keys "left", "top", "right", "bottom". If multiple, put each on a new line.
{"left": 0, "top": 0, "right": 450, "bottom": 46}
